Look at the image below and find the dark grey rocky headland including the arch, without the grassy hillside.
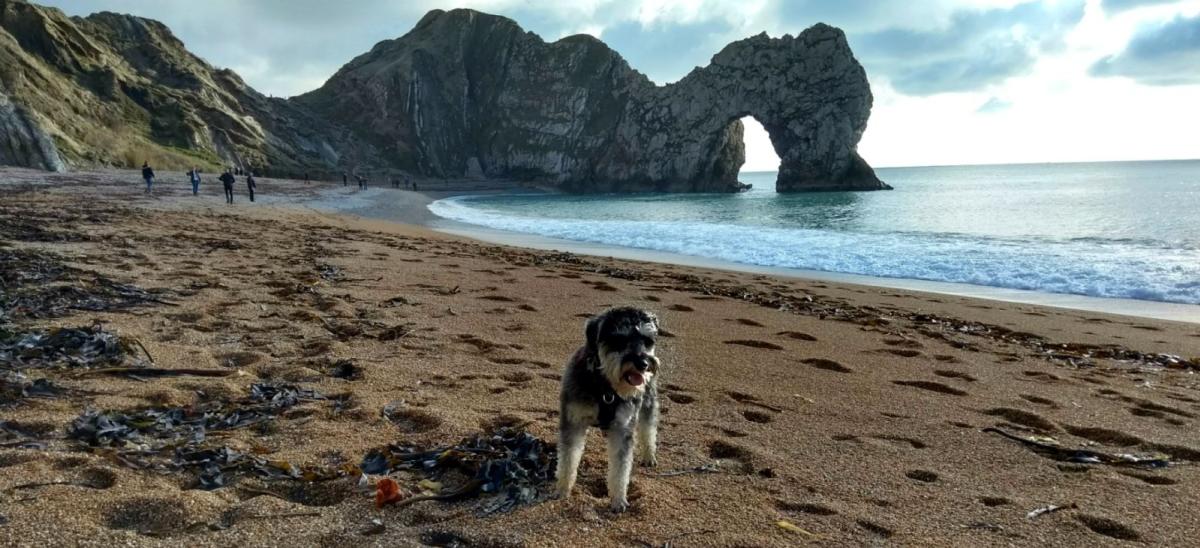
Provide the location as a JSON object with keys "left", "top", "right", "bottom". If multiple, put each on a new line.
{"left": 298, "top": 10, "right": 887, "bottom": 192}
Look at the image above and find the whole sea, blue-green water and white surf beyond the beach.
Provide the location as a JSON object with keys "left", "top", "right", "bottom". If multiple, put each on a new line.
{"left": 430, "top": 161, "right": 1200, "bottom": 303}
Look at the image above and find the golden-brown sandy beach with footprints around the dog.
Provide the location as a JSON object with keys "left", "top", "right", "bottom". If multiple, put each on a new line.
{"left": 0, "top": 169, "right": 1200, "bottom": 546}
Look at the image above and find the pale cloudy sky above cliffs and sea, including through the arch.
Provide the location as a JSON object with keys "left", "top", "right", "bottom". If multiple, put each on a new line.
{"left": 40, "top": 0, "right": 1200, "bottom": 170}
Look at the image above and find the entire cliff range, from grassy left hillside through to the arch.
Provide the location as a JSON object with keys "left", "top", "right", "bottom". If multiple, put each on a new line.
{"left": 0, "top": 0, "right": 887, "bottom": 192}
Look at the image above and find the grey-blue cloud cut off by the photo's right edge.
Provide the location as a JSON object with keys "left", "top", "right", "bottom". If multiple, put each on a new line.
{"left": 1088, "top": 16, "right": 1200, "bottom": 85}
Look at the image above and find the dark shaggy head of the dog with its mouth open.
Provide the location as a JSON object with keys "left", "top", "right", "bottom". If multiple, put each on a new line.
{"left": 584, "top": 307, "right": 659, "bottom": 398}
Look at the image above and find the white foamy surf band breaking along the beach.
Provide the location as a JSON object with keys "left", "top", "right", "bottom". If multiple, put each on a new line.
{"left": 428, "top": 197, "right": 1200, "bottom": 305}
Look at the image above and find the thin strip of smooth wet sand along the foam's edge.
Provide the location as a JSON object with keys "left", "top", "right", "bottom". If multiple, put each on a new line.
{"left": 304, "top": 185, "right": 1200, "bottom": 324}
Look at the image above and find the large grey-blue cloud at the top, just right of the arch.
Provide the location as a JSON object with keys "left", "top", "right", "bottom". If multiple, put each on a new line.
{"left": 850, "top": 1, "right": 1084, "bottom": 95}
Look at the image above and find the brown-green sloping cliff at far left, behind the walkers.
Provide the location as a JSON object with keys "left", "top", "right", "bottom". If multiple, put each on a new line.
{"left": 0, "top": 0, "right": 384, "bottom": 175}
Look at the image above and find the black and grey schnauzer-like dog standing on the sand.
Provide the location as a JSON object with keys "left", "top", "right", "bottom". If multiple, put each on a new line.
{"left": 556, "top": 307, "right": 660, "bottom": 512}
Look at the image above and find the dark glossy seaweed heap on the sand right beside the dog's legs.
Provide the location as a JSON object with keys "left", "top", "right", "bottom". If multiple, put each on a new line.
{"left": 360, "top": 427, "right": 556, "bottom": 513}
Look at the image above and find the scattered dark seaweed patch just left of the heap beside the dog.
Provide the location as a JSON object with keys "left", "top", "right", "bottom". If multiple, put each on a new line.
{"left": 67, "top": 383, "right": 343, "bottom": 489}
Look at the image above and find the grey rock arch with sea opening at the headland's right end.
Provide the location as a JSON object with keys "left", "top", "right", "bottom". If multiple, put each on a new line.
{"left": 601, "top": 24, "right": 889, "bottom": 192}
